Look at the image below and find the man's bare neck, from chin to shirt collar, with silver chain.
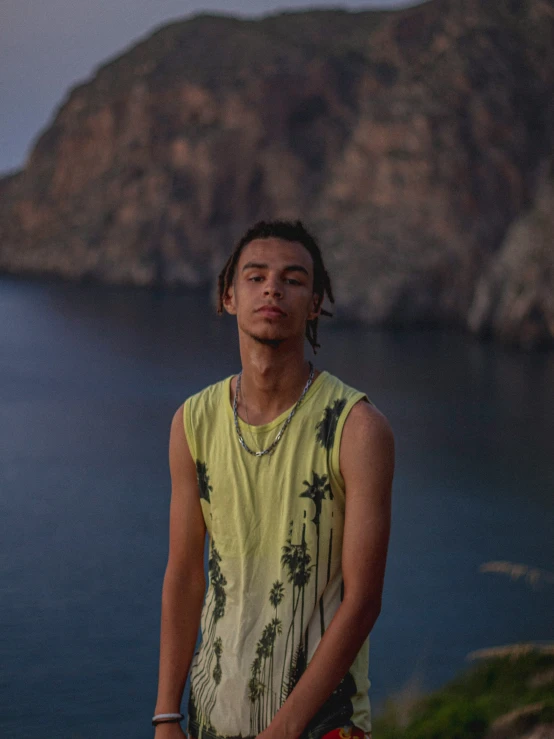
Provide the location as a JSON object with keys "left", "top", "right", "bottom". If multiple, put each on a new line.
{"left": 234, "top": 337, "right": 317, "bottom": 426}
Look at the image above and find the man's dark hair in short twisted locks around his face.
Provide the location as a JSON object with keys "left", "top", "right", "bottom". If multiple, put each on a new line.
{"left": 217, "top": 220, "right": 335, "bottom": 354}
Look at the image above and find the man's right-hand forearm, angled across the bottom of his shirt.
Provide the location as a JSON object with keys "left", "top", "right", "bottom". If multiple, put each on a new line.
{"left": 269, "top": 600, "right": 379, "bottom": 739}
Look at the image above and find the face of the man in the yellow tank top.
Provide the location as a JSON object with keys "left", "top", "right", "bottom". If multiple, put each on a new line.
{"left": 224, "top": 238, "right": 319, "bottom": 350}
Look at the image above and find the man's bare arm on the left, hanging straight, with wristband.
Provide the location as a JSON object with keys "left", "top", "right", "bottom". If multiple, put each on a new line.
{"left": 155, "top": 406, "right": 206, "bottom": 739}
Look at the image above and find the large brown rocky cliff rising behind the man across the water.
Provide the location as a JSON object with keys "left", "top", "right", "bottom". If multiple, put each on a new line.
{"left": 0, "top": 0, "right": 554, "bottom": 347}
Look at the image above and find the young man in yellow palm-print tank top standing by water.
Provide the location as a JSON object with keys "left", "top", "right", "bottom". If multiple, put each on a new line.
{"left": 153, "top": 221, "right": 394, "bottom": 739}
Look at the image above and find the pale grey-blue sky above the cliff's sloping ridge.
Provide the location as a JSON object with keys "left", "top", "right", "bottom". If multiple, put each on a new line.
{"left": 0, "top": 0, "right": 416, "bottom": 174}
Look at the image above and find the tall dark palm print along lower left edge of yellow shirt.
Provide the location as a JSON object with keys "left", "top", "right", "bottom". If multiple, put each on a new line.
{"left": 191, "top": 539, "right": 227, "bottom": 726}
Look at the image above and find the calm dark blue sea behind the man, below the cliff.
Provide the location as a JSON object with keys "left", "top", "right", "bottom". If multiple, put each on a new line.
{"left": 0, "top": 278, "right": 554, "bottom": 739}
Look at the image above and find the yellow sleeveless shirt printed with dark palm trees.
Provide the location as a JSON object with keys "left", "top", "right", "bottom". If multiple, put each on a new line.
{"left": 183, "top": 371, "right": 371, "bottom": 739}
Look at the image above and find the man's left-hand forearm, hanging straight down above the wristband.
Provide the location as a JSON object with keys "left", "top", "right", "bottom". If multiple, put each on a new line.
{"left": 156, "top": 570, "right": 205, "bottom": 713}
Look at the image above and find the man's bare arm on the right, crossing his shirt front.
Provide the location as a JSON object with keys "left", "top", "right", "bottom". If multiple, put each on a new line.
{"left": 259, "top": 402, "right": 394, "bottom": 739}
